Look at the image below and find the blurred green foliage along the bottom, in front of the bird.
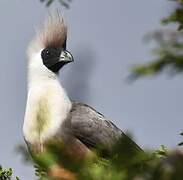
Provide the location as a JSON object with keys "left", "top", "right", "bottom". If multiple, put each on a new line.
{"left": 15, "top": 137, "right": 183, "bottom": 180}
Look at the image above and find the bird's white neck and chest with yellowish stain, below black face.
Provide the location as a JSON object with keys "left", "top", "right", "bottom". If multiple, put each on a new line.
{"left": 23, "top": 51, "right": 71, "bottom": 144}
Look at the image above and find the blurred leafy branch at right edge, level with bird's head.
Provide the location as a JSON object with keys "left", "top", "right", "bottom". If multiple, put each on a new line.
{"left": 131, "top": 30, "right": 183, "bottom": 78}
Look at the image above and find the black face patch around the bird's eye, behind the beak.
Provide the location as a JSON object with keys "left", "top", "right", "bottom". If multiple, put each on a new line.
{"left": 41, "top": 47, "right": 68, "bottom": 72}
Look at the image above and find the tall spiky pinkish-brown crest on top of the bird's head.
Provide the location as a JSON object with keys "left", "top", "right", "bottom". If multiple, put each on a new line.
{"left": 27, "top": 11, "right": 67, "bottom": 56}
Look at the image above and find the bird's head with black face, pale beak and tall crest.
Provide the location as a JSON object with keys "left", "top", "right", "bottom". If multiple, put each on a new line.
{"left": 28, "top": 13, "right": 73, "bottom": 73}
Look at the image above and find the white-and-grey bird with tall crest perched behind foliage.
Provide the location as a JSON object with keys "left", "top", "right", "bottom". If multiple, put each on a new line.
{"left": 23, "top": 12, "right": 141, "bottom": 179}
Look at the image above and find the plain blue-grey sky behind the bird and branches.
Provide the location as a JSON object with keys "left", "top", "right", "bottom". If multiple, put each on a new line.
{"left": 0, "top": 0, "right": 183, "bottom": 180}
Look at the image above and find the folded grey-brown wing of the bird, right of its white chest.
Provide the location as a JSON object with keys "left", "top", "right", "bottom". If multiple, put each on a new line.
{"left": 71, "top": 102, "right": 140, "bottom": 150}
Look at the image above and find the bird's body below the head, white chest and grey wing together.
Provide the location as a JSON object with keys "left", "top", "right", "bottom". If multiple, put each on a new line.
{"left": 23, "top": 73, "right": 122, "bottom": 152}
